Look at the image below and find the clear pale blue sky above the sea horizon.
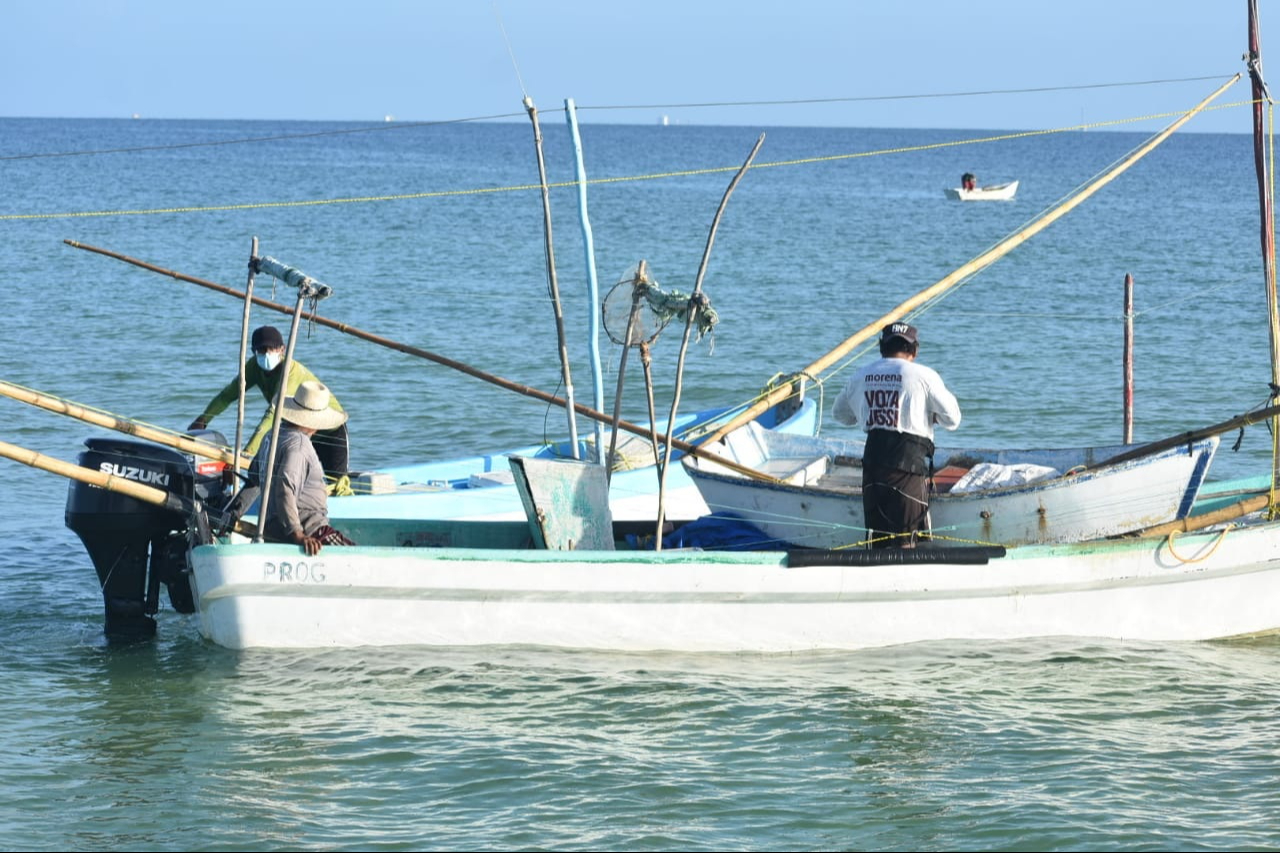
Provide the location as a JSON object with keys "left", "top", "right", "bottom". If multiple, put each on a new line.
{"left": 0, "top": 0, "right": 1259, "bottom": 132}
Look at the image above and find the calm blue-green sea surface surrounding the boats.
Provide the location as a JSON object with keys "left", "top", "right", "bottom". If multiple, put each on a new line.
{"left": 0, "top": 111, "right": 1280, "bottom": 850}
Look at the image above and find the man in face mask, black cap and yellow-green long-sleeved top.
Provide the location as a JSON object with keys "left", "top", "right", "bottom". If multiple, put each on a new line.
{"left": 187, "top": 325, "right": 348, "bottom": 492}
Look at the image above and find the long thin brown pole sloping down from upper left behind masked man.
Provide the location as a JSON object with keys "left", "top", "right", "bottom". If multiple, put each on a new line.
{"left": 63, "top": 240, "right": 780, "bottom": 483}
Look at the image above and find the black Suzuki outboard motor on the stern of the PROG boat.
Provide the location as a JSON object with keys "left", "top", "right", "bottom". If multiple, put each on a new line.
{"left": 65, "top": 430, "right": 227, "bottom": 638}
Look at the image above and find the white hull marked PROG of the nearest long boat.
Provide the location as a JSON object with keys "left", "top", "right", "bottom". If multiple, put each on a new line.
{"left": 192, "top": 523, "right": 1280, "bottom": 652}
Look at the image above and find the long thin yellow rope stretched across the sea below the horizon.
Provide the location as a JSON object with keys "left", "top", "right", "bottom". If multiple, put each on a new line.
{"left": 0, "top": 101, "right": 1252, "bottom": 220}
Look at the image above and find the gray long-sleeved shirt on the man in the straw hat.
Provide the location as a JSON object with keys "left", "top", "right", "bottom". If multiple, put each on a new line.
{"left": 255, "top": 424, "right": 329, "bottom": 542}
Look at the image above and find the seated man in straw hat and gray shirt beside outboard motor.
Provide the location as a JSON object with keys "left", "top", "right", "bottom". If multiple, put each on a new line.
{"left": 251, "top": 379, "right": 356, "bottom": 557}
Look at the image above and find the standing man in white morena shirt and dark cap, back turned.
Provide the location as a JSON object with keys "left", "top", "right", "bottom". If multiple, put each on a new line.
{"left": 831, "top": 323, "right": 960, "bottom": 548}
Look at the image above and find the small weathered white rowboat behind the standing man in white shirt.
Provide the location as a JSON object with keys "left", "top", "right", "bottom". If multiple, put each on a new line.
{"left": 682, "top": 424, "right": 1219, "bottom": 548}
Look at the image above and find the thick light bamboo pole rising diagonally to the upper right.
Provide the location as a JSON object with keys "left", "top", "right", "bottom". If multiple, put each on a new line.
{"left": 707, "top": 74, "right": 1240, "bottom": 443}
